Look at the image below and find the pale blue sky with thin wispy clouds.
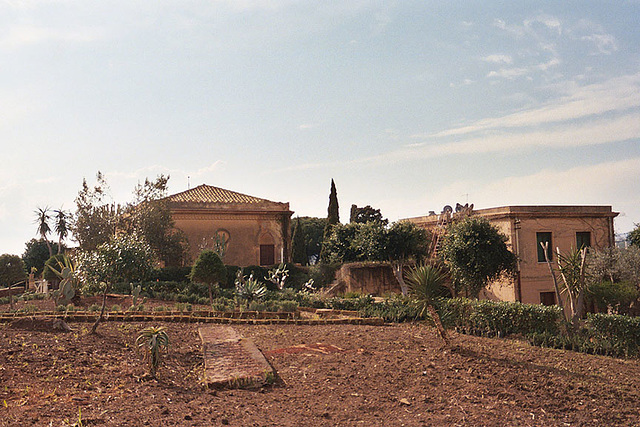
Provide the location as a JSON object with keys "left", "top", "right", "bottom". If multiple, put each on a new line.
{"left": 0, "top": 0, "right": 640, "bottom": 254}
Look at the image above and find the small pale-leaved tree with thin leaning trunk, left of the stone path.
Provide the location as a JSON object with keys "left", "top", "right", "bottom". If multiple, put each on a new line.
{"left": 78, "top": 234, "right": 154, "bottom": 333}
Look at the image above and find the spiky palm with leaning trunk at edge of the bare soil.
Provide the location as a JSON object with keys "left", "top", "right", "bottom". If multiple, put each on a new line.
{"left": 405, "top": 264, "right": 449, "bottom": 347}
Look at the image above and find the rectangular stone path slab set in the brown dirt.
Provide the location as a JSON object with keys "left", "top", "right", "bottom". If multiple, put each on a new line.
{"left": 198, "top": 326, "right": 275, "bottom": 387}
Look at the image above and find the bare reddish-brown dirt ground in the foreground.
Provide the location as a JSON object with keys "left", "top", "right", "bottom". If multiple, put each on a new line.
{"left": 0, "top": 310, "right": 640, "bottom": 426}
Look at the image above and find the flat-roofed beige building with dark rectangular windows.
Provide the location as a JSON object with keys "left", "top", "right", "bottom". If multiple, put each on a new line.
{"left": 408, "top": 206, "right": 618, "bottom": 305}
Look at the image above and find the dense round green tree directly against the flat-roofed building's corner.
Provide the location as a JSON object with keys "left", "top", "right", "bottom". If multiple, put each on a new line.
{"left": 442, "top": 217, "right": 516, "bottom": 298}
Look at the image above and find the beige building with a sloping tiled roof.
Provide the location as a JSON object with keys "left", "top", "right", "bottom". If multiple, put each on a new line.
{"left": 165, "top": 184, "right": 293, "bottom": 267}
